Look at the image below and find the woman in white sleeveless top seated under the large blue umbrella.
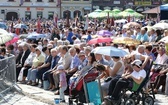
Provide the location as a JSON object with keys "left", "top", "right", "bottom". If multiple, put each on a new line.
{"left": 99, "top": 56, "right": 125, "bottom": 95}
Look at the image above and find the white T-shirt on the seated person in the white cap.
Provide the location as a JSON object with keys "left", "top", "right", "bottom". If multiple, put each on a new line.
{"left": 131, "top": 70, "right": 146, "bottom": 79}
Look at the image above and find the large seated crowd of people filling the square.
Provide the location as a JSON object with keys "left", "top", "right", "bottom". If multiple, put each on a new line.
{"left": 0, "top": 17, "right": 168, "bottom": 102}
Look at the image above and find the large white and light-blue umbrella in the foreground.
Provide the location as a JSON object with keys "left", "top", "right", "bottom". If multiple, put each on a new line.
{"left": 92, "top": 46, "right": 128, "bottom": 57}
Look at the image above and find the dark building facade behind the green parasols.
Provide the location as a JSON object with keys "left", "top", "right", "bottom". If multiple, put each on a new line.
{"left": 92, "top": 0, "right": 163, "bottom": 12}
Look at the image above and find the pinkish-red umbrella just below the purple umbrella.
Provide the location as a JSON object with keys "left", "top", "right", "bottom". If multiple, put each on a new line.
{"left": 88, "top": 37, "right": 112, "bottom": 44}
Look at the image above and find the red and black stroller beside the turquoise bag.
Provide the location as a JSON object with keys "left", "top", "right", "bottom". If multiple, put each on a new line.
{"left": 69, "top": 67, "right": 99, "bottom": 105}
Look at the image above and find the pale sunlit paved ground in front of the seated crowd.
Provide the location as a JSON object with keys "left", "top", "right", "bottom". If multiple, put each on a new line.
{"left": 0, "top": 84, "right": 168, "bottom": 105}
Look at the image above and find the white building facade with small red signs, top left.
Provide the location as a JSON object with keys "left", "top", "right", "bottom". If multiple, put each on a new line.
{"left": 0, "top": 0, "right": 60, "bottom": 20}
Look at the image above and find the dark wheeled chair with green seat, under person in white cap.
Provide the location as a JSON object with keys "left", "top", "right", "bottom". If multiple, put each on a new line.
{"left": 102, "top": 61, "right": 154, "bottom": 105}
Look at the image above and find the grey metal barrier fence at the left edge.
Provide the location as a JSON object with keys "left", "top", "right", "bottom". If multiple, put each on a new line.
{"left": 0, "top": 55, "right": 21, "bottom": 100}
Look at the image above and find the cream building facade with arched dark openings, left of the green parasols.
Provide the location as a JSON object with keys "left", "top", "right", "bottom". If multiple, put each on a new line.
{"left": 61, "top": 0, "right": 92, "bottom": 18}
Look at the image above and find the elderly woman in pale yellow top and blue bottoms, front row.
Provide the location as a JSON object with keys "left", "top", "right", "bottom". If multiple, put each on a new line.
{"left": 27, "top": 47, "right": 45, "bottom": 86}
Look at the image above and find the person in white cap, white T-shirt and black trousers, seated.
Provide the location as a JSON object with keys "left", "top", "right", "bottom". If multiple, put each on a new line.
{"left": 108, "top": 60, "right": 146, "bottom": 102}
